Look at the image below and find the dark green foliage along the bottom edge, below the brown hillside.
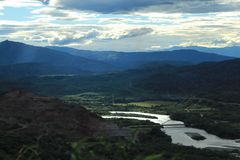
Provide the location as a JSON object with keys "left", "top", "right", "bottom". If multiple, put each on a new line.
{"left": 0, "top": 120, "right": 239, "bottom": 160}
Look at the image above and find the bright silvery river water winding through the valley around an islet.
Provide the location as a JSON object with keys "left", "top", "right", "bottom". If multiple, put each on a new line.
{"left": 102, "top": 111, "right": 240, "bottom": 150}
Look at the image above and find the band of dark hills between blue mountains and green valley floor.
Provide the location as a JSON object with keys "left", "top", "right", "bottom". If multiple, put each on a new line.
{"left": 9, "top": 59, "right": 240, "bottom": 102}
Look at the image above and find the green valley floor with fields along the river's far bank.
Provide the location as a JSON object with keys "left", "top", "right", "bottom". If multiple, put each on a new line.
{"left": 62, "top": 93, "right": 240, "bottom": 139}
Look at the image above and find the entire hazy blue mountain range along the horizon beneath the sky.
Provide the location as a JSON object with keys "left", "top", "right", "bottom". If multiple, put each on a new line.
{"left": 0, "top": 40, "right": 236, "bottom": 78}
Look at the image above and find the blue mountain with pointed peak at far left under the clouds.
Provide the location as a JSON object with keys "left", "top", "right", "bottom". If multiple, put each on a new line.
{"left": 0, "top": 41, "right": 114, "bottom": 73}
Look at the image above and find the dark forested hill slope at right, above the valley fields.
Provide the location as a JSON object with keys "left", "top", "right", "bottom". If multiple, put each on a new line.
{"left": 131, "top": 59, "right": 240, "bottom": 101}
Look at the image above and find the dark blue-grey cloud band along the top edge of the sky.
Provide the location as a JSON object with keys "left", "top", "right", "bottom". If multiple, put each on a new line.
{"left": 45, "top": 0, "right": 240, "bottom": 13}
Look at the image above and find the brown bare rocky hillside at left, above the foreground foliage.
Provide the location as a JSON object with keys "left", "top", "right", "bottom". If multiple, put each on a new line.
{"left": 0, "top": 91, "right": 123, "bottom": 140}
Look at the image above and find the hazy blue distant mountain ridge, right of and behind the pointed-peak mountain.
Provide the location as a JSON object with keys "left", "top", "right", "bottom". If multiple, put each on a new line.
{"left": 47, "top": 47, "right": 232, "bottom": 69}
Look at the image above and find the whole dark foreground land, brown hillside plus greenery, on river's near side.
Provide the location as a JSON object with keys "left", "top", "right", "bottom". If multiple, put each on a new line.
{"left": 0, "top": 92, "right": 239, "bottom": 160}
